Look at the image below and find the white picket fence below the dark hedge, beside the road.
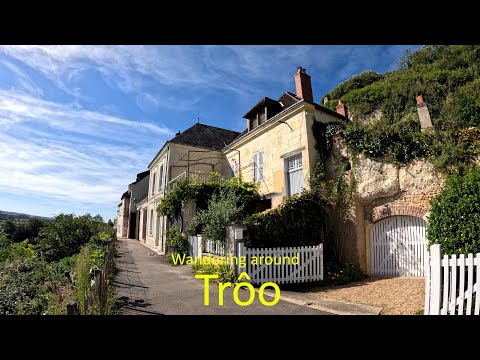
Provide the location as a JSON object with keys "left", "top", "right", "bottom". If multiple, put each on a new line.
{"left": 237, "top": 242, "right": 323, "bottom": 284}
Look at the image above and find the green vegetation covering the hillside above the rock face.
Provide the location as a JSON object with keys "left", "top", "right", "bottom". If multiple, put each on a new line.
{"left": 324, "top": 45, "right": 480, "bottom": 172}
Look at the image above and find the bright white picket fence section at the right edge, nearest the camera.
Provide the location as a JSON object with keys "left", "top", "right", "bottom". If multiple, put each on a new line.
{"left": 424, "top": 245, "right": 480, "bottom": 315}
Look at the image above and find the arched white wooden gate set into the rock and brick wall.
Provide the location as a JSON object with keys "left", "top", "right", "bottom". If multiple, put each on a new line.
{"left": 371, "top": 216, "right": 427, "bottom": 276}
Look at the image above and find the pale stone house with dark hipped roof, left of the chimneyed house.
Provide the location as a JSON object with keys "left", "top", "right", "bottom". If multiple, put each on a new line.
{"left": 140, "top": 122, "right": 239, "bottom": 252}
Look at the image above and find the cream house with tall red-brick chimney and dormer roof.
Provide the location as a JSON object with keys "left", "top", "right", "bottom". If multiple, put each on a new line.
{"left": 224, "top": 68, "right": 348, "bottom": 207}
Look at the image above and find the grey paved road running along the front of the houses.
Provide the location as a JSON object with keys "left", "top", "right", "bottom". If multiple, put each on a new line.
{"left": 114, "top": 239, "right": 329, "bottom": 315}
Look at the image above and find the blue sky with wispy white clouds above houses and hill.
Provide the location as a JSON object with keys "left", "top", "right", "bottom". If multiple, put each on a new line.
{"left": 0, "top": 45, "right": 419, "bottom": 220}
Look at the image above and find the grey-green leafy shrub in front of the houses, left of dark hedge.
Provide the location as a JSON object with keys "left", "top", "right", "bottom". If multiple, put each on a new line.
{"left": 187, "top": 188, "right": 244, "bottom": 246}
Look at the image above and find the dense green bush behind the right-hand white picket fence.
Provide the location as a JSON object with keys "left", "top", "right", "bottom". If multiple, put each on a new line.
{"left": 427, "top": 168, "right": 480, "bottom": 255}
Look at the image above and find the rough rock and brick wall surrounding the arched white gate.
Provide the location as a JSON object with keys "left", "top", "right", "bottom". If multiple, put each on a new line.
{"left": 327, "top": 138, "right": 445, "bottom": 272}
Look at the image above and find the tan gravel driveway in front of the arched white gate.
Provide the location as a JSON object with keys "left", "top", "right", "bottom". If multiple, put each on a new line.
{"left": 308, "top": 276, "right": 425, "bottom": 315}
